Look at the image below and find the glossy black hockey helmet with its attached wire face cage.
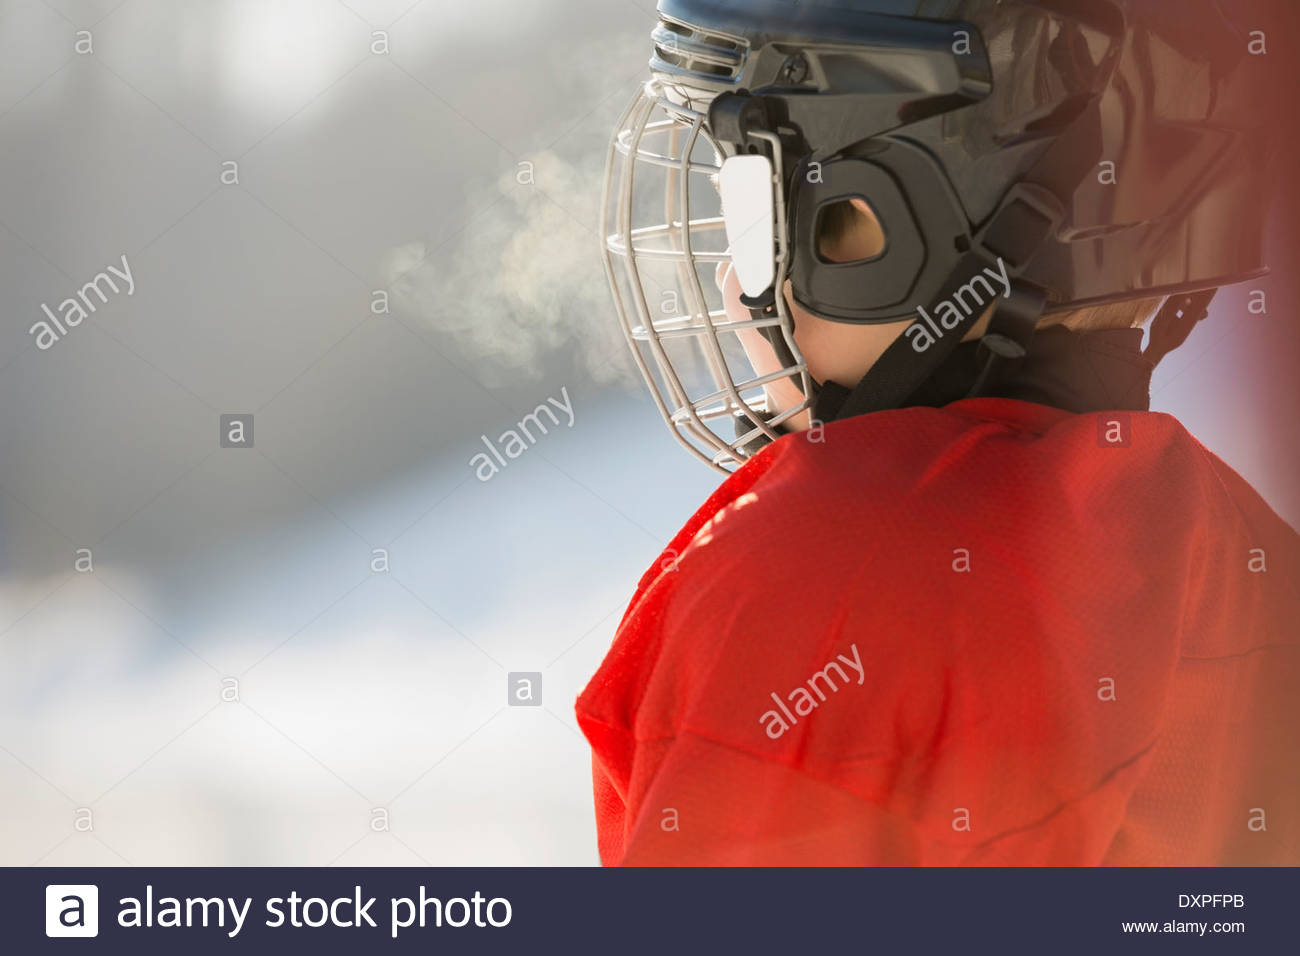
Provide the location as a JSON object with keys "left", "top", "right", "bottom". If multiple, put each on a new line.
{"left": 606, "top": 0, "right": 1279, "bottom": 467}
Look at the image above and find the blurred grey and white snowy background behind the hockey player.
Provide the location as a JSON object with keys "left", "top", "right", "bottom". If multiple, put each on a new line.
{"left": 0, "top": 0, "right": 1300, "bottom": 865}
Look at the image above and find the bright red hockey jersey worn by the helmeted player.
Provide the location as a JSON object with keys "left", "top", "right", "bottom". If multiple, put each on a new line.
{"left": 577, "top": 398, "right": 1300, "bottom": 865}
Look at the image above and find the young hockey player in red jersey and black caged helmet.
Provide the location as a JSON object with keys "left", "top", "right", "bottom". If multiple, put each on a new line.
{"left": 577, "top": 0, "right": 1300, "bottom": 865}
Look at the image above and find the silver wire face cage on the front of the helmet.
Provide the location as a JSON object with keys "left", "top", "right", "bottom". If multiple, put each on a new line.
{"left": 602, "top": 79, "right": 813, "bottom": 472}
